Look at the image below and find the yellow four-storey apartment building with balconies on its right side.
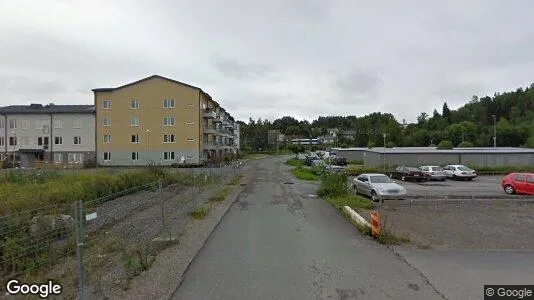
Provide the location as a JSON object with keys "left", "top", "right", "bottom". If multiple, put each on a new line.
{"left": 93, "top": 75, "right": 240, "bottom": 166}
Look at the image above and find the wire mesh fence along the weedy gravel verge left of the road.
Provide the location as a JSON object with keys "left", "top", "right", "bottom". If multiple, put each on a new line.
{"left": 0, "top": 163, "right": 246, "bottom": 299}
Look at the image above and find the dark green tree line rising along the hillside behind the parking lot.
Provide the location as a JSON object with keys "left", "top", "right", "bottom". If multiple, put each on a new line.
{"left": 240, "top": 84, "right": 534, "bottom": 151}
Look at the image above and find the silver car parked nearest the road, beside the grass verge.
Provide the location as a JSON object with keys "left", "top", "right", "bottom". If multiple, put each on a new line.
{"left": 352, "top": 173, "right": 407, "bottom": 201}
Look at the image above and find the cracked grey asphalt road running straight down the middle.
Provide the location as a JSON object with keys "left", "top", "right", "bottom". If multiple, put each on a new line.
{"left": 173, "top": 157, "right": 443, "bottom": 300}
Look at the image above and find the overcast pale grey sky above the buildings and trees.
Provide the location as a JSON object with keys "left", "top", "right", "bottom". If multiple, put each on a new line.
{"left": 0, "top": 0, "right": 534, "bottom": 122}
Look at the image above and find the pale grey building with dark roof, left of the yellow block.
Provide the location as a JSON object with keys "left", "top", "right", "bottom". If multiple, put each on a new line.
{"left": 0, "top": 104, "right": 95, "bottom": 168}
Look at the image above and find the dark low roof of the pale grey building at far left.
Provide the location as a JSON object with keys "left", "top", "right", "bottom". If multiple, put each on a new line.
{"left": 0, "top": 104, "right": 95, "bottom": 114}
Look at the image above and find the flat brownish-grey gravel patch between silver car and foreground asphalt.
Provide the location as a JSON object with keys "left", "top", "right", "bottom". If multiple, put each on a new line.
{"left": 362, "top": 200, "right": 534, "bottom": 250}
